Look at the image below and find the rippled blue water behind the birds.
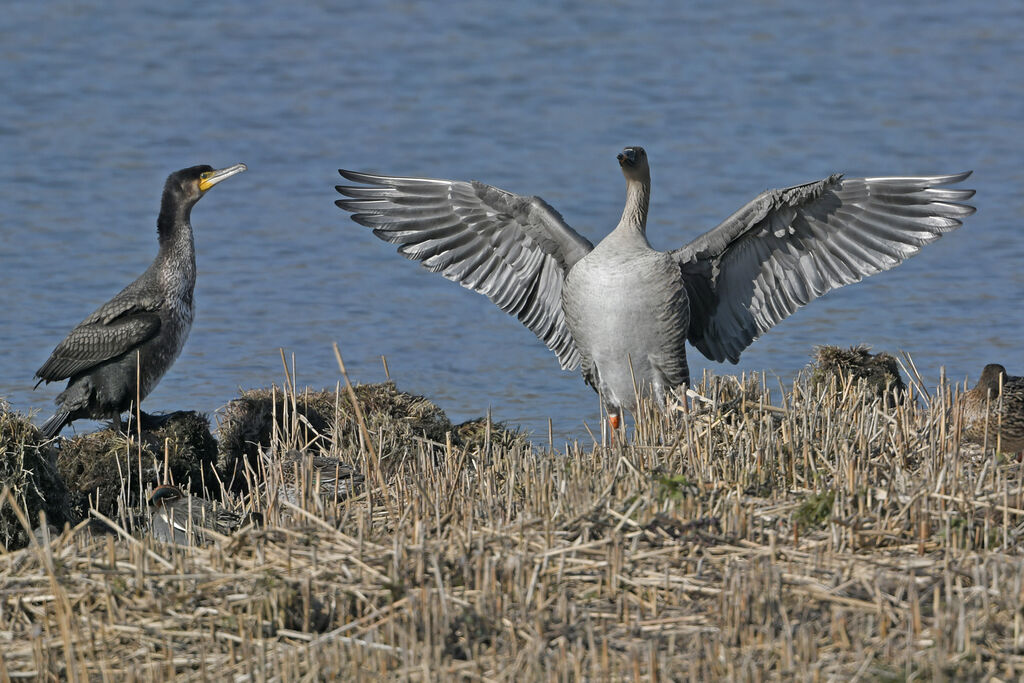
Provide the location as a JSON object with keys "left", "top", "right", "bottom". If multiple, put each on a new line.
{"left": 0, "top": 0, "right": 1024, "bottom": 438}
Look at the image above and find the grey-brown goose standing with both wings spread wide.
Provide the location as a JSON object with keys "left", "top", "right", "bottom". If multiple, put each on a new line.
{"left": 336, "top": 146, "right": 974, "bottom": 427}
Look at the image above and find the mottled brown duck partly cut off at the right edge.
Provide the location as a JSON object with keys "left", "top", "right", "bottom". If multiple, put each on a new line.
{"left": 964, "top": 364, "right": 1024, "bottom": 453}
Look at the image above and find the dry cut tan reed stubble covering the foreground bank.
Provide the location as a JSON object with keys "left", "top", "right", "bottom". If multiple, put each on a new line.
{"left": 0, "top": 360, "right": 1024, "bottom": 681}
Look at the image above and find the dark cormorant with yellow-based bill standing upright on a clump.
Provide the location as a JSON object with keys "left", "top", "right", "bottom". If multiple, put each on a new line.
{"left": 36, "top": 164, "right": 246, "bottom": 436}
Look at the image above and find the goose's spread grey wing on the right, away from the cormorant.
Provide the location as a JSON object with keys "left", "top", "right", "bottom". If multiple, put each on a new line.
{"left": 672, "top": 171, "right": 975, "bottom": 362}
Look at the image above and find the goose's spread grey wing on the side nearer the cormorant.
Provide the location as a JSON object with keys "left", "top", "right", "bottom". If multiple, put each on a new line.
{"left": 335, "top": 170, "right": 593, "bottom": 370}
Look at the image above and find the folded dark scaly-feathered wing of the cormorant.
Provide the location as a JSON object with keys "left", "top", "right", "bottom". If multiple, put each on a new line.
{"left": 36, "top": 293, "right": 160, "bottom": 386}
